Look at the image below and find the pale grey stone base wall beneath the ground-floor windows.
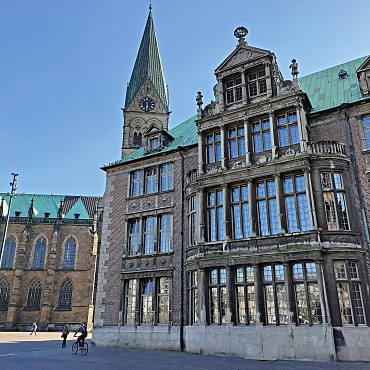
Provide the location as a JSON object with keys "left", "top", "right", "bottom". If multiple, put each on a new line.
{"left": 92, "top": 325, "right": 370, "bottom": 361}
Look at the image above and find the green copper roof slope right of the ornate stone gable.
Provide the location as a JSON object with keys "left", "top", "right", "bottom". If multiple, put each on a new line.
{"left": 299, "top": 56, "right": 369, "bottom": 113}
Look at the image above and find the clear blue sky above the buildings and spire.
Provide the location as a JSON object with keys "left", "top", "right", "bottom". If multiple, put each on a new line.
{"left": 0, "top": 0, "right": 370, "bottom": 195}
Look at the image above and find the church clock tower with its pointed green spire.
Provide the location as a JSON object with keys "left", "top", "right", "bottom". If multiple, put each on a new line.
{"left": 122, "top": 6, "right": 170, "bottom": 158}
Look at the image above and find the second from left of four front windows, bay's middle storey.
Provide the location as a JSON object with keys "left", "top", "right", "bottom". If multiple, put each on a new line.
{"left": 231, "top": 185, "right": 251, "bottom": 239}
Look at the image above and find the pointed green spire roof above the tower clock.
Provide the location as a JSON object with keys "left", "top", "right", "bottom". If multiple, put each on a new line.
{"left": 125, "top": 11, "right": 169, "bottom": 112}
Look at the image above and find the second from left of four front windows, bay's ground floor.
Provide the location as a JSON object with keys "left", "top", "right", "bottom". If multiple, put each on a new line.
{"left": 235, "top": 266, "right": 257, "bottom": 325}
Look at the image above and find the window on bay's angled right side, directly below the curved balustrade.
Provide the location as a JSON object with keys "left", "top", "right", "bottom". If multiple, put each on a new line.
{"left": 321, "top": 172, "right": 350, "bottom": 230}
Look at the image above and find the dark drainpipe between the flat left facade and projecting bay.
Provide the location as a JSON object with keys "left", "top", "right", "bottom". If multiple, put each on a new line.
{"left": 177, "top": 145, "right": 185, "bottom": 352}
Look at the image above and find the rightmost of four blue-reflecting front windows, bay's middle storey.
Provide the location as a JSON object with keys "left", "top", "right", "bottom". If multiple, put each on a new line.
{"left": 284, "top": 176, "right": 310, "bottom": 233}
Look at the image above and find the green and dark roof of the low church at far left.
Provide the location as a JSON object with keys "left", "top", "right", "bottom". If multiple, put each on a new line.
{"left": 0, "top": 193, "right": 101, "bottom": 220}
